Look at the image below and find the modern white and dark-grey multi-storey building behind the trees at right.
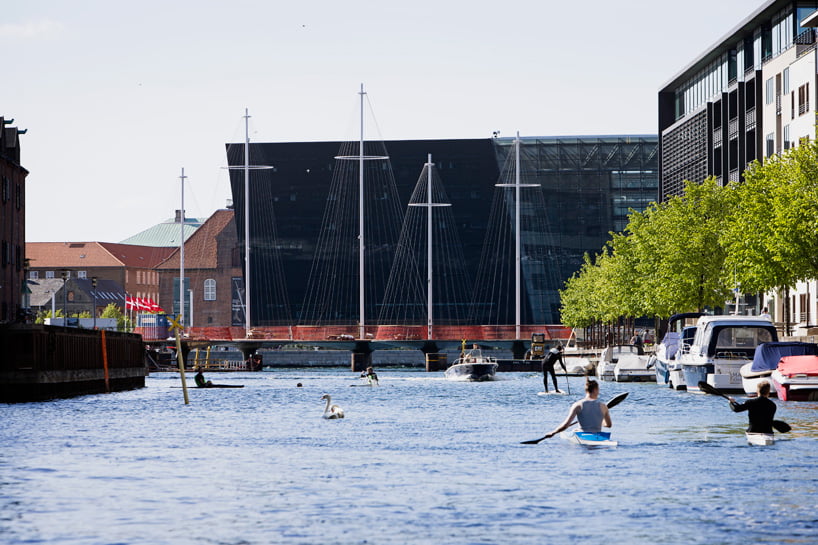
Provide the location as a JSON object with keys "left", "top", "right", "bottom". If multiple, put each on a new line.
{"left": 659, "top": 0, "right": 818, "bottom": 333}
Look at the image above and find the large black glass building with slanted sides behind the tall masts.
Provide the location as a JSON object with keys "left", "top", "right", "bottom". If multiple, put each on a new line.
{"left": 227, "top": 135, "right": 658, "bottom": 326}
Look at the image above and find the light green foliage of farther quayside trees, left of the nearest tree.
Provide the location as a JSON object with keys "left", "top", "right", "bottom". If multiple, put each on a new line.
{"left": 560, "top": 178, "right": 737, "bottom": 327}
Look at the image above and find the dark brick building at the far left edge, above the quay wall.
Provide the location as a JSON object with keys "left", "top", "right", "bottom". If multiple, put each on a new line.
{"left": 0, "top": 117, "right": 28, "bottom": 323}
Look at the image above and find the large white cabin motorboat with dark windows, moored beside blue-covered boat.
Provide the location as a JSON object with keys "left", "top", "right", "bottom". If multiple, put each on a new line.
{"left": 678, "top": 315, "right": 778, "bottom": 392}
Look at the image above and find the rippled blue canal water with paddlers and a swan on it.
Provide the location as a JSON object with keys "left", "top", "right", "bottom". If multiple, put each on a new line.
{"left": 0, "top": 368, "right": 818, "bottom": 545}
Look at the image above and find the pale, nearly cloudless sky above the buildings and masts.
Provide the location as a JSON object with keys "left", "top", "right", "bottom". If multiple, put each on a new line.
{"left": 6, "top": 0, "right": 762, "bottom": 242}
